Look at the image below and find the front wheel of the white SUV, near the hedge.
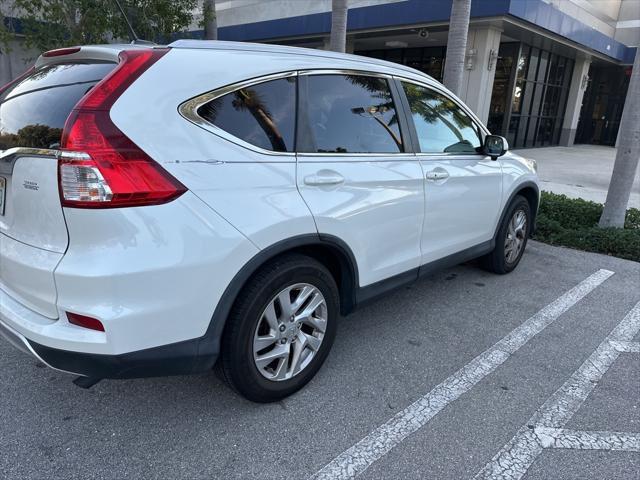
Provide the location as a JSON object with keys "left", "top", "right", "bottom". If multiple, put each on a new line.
{"left": 480, "top": 195, "right": 531, "bottom": 274}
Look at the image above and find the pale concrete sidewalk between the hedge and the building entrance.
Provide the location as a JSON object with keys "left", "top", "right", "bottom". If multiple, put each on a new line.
{"left": 514, "top": 145, "right": 640, "bottom": 208}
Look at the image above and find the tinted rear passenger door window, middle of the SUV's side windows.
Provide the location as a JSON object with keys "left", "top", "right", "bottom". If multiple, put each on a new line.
{"left": 298, "top": 75, "right": 403, "bottom": 153}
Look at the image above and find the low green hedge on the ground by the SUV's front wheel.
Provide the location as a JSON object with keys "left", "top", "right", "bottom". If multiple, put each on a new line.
{"left": 533, "top": 192, "right": 640, "bottom": 262}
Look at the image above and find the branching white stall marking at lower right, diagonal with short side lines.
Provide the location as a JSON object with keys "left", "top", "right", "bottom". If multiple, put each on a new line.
{"left": 474, "top": 302, "right": 640, "bottom": 480}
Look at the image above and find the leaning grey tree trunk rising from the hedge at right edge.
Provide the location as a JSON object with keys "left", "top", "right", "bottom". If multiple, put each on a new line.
{"left": 599, "top": 52, "right": 640, "bottom": 228}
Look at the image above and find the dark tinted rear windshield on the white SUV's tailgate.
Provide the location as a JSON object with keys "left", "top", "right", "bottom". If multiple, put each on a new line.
{"left": 0, "top": 63, "right": 116, "bottom": 150}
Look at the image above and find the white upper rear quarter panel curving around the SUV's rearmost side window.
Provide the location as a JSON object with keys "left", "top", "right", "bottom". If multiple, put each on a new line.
{"left": 111, "top": 49, "right": 408, "bottom": 249}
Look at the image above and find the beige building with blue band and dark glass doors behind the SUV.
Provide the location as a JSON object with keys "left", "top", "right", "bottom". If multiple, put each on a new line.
{"left": 201, "top": 0, "right": 640, "bottom": 148}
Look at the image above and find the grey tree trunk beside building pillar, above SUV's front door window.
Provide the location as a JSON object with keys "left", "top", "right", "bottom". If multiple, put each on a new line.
{"left": 443, "top": 0, "right": 471, "bottom": 96}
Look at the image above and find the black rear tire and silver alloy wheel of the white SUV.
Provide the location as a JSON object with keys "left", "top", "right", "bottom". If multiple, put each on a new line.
{"left": 221, "top": 254, "right": 340, "bottom": 403}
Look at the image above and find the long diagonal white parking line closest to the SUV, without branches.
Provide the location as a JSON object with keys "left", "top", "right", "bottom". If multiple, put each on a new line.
{"left": 312, "top": 270, "right": 613, "bottom": 479}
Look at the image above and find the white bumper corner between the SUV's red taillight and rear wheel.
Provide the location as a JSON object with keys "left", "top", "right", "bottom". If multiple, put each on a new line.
{"left": 55, "top": 192, "right": 257, "bottom": 354}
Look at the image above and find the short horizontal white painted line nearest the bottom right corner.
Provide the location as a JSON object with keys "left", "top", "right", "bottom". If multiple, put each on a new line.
{"left": 535, "top": 427, "right": 640, "bottom": 452}
